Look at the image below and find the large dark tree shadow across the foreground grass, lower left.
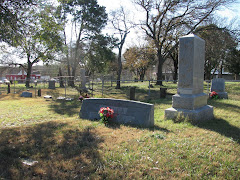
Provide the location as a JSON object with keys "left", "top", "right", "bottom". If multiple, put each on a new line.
{"left": 0, "top": 122, "right": 103, "bottom": 179}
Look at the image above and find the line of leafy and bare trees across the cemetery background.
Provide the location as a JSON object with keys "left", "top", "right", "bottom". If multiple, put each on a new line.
{"left": 0, "top": 0, "right": 240, "bottom": 89}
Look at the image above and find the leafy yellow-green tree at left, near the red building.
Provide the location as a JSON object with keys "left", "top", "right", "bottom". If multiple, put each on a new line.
{"left": 3, "top": 3, "right": 63, "bottom": 87}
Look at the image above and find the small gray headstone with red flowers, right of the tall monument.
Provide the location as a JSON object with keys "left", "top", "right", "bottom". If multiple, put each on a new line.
{"left": 211, "top": 78, "right": 228, "bottom": 99}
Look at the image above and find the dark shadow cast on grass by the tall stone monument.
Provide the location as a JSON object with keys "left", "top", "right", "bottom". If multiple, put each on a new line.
{"left": 197, "top": 119, "right": 240, "bottom": 144}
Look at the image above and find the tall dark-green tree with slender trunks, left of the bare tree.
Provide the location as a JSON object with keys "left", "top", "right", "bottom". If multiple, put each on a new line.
{"left": 58, "top": 0, "right": 107, "bottom": 86}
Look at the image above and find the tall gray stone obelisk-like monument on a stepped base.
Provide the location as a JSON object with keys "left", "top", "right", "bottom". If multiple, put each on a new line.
{"left": 165, "top": 34, "right": 214, "bottom": 122}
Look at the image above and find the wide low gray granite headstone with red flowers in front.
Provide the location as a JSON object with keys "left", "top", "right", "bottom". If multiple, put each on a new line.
{"left": 79, "top": 98, "right": 154, "bottom": 127}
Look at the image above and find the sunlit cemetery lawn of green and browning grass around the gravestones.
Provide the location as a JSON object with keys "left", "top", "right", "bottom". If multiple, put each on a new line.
{"left": 0, "top": 83, "right": 240, "bottom": 179}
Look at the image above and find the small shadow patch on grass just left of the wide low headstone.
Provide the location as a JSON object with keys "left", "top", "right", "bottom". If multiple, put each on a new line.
{"left": 49, "top": 100, "right": 81, "bottom": 116}
